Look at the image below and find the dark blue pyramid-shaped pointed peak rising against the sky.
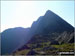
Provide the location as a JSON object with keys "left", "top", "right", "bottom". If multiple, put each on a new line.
{"left": 31, "top": 10, "right": 74, "bottom": 34}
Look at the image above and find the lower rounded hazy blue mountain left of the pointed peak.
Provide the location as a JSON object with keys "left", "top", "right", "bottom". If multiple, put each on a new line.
{"left": 1, "top": 27, "right": 29, "bottom": 54}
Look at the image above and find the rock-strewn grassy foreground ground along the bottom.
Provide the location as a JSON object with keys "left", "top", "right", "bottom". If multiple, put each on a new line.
{"left": 13, "top": 42, "right": 75, "bottom": 55}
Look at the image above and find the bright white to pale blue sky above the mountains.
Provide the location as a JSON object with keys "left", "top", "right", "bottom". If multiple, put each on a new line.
{"left": 1, "top": 1, "right": 74, "bottom": 32}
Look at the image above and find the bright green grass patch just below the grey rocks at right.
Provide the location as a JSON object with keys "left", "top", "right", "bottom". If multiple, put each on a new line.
{"left": 52, "top": 43, "right": 74, "bottom": 52}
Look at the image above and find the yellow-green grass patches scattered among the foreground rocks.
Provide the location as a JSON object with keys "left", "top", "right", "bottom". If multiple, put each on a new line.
{"left": 15, "top": 42, "right": 75, "bottom": 55}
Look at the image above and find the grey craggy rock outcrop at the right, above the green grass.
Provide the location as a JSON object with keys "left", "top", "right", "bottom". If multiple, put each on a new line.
{"left": 56, "top": 31, "right": 75, "bottom": 44}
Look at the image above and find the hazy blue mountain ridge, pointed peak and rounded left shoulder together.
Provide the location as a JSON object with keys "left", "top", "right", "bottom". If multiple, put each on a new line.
{"left": 1, "top": 10, "right": 74, "bottom": 54}
